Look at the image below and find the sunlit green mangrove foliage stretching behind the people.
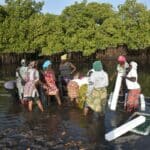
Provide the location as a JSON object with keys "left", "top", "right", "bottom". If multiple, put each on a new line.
{"left": 0, "top": 0, "right": 150, "bottom": 55}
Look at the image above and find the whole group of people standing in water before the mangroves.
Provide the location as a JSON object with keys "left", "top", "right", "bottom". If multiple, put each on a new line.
{"left": 16, "top": 54, "right": 140, "bottom": 115}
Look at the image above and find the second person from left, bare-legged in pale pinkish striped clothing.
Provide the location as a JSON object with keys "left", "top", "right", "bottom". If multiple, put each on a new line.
{"left": 24, "top": 61, "right": 44, "bottom": 112}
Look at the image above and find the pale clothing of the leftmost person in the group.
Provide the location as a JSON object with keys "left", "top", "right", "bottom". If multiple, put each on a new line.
{"left": 16, "top": 66, "right": 28, "bottom": 100}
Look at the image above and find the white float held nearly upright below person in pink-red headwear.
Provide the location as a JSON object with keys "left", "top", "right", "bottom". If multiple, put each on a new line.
{"left": 110, "top": 72, "right": 123, "bottom": 111}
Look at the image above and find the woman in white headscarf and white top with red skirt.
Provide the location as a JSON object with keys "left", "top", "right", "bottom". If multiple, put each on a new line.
{"left": 124, "top": 61, "right": 141, "bottom": 112}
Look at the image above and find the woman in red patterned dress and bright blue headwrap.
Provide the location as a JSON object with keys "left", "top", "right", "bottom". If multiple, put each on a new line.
{"left": 42, "top": 60, "right": 61, "bottom": 105}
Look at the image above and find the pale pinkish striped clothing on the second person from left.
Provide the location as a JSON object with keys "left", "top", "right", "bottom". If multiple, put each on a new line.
{"left": 24, "top": 68, "right": 39, "bottom": 100}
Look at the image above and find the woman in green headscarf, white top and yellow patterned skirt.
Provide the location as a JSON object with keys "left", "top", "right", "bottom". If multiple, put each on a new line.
{"left": 84, "top": 61, "right": 109, "bottom": 115}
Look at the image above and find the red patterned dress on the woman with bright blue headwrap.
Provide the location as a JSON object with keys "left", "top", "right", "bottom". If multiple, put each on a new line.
{"left": 44, "top": 70, "right": 58, "bottom": 95}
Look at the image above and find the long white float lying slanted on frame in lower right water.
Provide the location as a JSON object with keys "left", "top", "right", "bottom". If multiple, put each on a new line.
{"left": 105, "top": 116, "right": 146, "bottom": 141}
